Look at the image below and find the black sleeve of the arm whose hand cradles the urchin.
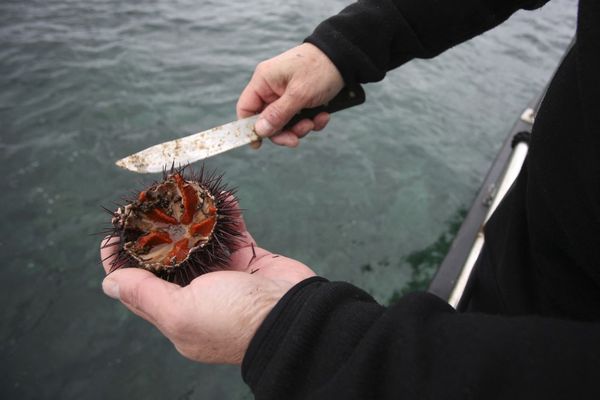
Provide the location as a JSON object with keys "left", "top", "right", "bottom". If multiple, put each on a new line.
{"left": 242, "top": 278, "right": 600, "bottom": 400}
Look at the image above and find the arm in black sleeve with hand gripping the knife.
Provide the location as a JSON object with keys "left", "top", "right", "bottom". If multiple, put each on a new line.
{"left": 237, "top": 0, "right": 548, "bottom": 147}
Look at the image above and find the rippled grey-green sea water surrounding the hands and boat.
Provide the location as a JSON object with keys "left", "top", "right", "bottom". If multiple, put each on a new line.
{"left": 0, "top": 0, "right": 576, "bottom": 399}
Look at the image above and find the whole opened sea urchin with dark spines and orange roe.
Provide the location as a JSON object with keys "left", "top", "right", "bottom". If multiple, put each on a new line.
{"left": 107, "top": 168, "right": 240, "bottom": 286}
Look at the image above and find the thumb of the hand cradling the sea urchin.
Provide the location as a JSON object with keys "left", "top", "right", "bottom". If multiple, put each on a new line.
{"left": 102, "top": 268, "right": 181, "bottom": 324}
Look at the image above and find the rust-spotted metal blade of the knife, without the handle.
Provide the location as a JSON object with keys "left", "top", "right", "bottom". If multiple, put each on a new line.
{"left": 116, "top": 115, "right": 260, "bottom": 173}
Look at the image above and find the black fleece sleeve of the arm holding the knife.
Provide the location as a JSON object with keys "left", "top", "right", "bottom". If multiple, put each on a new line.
{"left": 305, "top": 0, "right": 548, "bottom": 82}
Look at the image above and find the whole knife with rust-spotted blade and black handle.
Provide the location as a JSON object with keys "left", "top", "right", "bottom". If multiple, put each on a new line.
{"left": 116, "top": 84, "right": 365, "bottom": 173}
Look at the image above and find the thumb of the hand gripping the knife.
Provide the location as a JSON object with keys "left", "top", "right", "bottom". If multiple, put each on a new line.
{"left": 254, "top": 89, "right": 307, "bottom": 137}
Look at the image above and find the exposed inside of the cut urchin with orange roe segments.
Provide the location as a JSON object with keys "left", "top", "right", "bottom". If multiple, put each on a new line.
{"left": 129, "top": 173, "right": 218, "bottom": 269}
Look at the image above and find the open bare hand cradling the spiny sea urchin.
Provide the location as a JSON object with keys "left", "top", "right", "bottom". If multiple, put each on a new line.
{"left": 100, "top": 216, "right": 315, "bottom": 364}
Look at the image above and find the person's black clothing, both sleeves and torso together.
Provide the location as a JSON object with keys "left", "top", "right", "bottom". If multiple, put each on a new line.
{"left": 242, "top": 0, "right": 600, "bottom": 399}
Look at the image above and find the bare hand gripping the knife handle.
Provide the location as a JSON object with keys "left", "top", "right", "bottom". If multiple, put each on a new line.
{"left": 237, "top": 43, "right": 344, "bottom": 147}
